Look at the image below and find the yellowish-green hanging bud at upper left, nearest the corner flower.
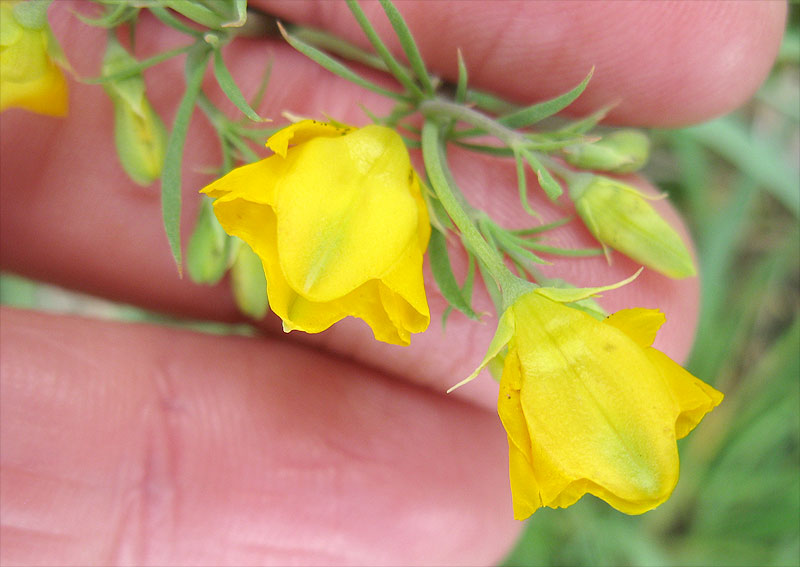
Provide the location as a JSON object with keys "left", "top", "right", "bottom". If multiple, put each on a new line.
{"left": 103, "top": 36, "right": 167, "bottom": 185}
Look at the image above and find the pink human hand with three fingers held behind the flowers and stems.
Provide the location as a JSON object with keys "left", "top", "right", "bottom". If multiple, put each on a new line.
{"left": 0, "top": 2, "right": 785, "bottom": 564}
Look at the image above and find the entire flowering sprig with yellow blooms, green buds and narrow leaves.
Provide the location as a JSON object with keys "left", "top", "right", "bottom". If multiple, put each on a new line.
{"left": 0, "top": 0, "right": 722, "bottom": 519}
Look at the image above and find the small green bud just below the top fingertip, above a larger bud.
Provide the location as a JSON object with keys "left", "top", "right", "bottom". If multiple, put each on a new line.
{"left": 564, "top": 130, "right": 650, "bottom": 173}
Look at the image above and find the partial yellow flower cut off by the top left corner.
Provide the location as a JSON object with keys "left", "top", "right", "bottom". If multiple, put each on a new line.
{"left": 0, "top": 1, "right": 68, "bottom": 116}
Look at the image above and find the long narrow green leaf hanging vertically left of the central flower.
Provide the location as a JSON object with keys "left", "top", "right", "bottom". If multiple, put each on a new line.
{"left": 161, "top": 46, "right": 211, "bottom": 274}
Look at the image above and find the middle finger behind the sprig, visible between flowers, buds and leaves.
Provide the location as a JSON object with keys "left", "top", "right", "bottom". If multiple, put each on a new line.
{"left": 0, "top": 2, "right": 756, "bottom": 408}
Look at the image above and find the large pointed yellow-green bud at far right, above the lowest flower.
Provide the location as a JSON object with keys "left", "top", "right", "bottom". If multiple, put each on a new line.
{"left": 570, "top": 176, "right": 697, "bottom": 279}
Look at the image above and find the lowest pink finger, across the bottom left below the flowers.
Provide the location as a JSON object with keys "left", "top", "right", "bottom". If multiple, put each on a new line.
{"left": 0, "top": 310, "right": 519, "bottom": 565}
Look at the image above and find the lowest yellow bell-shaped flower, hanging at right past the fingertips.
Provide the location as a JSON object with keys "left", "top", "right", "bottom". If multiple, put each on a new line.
{"left": 472, "top": 288, "right": 723, "bottom": 520}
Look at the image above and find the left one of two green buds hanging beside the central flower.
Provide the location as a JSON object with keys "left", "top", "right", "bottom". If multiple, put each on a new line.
{"left": 186, "top": 198, "right": 231, "bottom": 285}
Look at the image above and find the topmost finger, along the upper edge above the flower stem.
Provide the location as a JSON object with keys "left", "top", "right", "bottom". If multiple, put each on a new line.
{"left": 253, "top": 0, "right": 786, "bottom": 126}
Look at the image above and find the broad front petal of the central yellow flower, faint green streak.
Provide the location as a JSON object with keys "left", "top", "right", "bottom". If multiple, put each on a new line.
{"left": 276, "top": 126, "right": 418, "bottom": 302}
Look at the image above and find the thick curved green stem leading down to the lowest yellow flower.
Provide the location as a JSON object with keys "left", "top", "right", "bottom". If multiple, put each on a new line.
{"left": 422, "top": 118, "right": 534, "bottom": 307}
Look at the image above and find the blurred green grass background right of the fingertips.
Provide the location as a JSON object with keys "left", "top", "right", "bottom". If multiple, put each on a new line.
{"left": 504, "top": 10, "right": 800, "bottom": 566}
